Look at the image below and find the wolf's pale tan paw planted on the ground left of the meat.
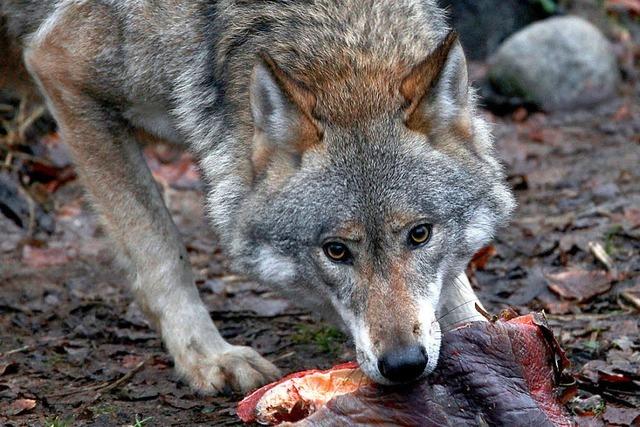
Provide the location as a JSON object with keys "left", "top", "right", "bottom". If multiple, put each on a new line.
{"left": 176, "top": 346, "right": 280, "bottom": 394}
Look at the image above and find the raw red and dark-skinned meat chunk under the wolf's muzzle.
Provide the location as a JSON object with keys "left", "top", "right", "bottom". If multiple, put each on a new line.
{"left": 238, "top": 315, "right": 572, "bottom": 426}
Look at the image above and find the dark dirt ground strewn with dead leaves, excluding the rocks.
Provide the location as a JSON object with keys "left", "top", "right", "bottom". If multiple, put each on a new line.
{"left": 0, "top": 30, "right": 640, "bottom": 427}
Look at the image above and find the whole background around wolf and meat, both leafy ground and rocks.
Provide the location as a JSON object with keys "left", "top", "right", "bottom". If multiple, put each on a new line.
{"left": 0, "top": 0, "right": 640, "bottom": 426}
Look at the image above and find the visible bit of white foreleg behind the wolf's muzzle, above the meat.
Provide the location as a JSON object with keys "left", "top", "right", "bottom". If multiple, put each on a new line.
{"left": 438, "top": 272, "right": 486, "bottom": 331}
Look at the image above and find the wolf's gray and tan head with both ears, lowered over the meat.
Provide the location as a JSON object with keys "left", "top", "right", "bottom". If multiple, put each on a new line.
{"left": 212, "top": 34, "right": 514, "bottom": 384}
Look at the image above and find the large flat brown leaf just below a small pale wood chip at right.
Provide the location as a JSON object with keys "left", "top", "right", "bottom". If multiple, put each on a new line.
{"left": 546, "top": 268, "right": 613, "bottom": 302}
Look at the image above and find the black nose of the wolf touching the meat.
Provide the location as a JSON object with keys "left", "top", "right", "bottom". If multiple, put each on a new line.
{"left": 378, "top": 345, "right": 429, "bottom": 383}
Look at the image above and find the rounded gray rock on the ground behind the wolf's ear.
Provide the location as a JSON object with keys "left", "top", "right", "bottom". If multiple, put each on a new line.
{"left": 489, "top": 16, "right": 620, "bottom": 111}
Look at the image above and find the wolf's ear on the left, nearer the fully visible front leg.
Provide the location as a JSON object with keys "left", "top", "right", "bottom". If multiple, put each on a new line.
{"left": 250, "top": 54, "right": 322, "bottom": 175}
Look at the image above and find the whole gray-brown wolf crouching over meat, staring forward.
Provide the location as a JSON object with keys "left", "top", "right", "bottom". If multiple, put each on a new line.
{"left": 0, "top": 0, "right": 514, "bottom": 393}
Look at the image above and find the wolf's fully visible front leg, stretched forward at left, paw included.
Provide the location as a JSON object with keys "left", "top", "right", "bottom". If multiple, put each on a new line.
{"left": 26, "top": 30, "right": 278, "bottom": 392}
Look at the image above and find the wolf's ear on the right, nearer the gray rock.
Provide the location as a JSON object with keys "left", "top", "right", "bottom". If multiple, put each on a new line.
{"left": 400, "top": 31, "right": 470, "bottom": 134}
